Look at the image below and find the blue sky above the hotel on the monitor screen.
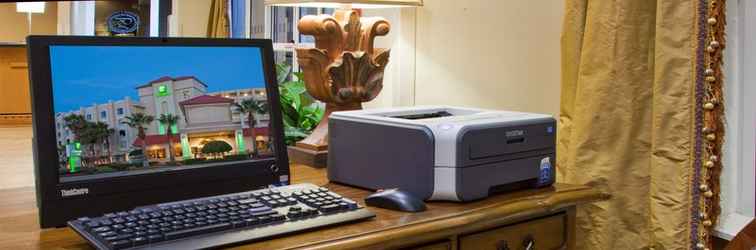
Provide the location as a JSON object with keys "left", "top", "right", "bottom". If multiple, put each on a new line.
{"left": 50, "top": 45, "right": 265, "bottom": 112}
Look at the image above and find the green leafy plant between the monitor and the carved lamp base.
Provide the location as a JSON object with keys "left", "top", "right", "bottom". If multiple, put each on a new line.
{"left": 276, "top": 64, "right": 325, "bottom": 145}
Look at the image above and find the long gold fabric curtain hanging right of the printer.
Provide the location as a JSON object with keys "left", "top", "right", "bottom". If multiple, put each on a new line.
{"left": 557, "top": 0, "right": 722, "bottom": 249}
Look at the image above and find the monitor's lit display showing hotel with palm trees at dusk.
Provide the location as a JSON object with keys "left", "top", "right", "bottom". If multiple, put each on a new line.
{"left": 49, "top": 45, "right": 275, "bottom": 182}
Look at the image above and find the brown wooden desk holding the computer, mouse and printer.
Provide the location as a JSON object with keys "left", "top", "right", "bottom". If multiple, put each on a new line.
{"left": 0, "top": 165, "right": 607, "bottom": 250}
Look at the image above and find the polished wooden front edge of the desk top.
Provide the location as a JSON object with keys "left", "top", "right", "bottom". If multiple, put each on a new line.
{"left": 284, "top": 187, "right": 611, "bottom": 249}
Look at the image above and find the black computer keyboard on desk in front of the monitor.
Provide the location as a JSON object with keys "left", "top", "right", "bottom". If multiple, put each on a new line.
{"left": 68, "top": 184, "right": 375, "bottom": 249}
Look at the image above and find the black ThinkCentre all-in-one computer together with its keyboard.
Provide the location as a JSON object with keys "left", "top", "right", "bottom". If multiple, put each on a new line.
{"left": 27, "top": 36, "right": 374, "bottom": 249}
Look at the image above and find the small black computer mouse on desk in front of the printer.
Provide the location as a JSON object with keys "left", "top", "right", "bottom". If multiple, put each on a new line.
{"left": 365, "top": 188, "right": 425, "bottom": 212}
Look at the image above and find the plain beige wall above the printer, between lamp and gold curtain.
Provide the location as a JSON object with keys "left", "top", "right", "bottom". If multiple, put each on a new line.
{"left": 415, "top": 0, "right": 563, "bottom": 115}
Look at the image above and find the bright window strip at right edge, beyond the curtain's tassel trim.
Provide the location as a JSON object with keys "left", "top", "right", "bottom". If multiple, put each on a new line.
{"left": 714, "top": 0, "right": 756, "bottom": 240}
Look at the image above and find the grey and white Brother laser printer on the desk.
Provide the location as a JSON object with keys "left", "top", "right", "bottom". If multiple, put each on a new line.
{"left": 328, "top": 106, "right": 556, "bottom": 201}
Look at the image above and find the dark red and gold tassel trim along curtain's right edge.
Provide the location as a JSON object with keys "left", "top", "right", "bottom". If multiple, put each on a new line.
{"left": 691, "top": 0, "right": 725, "bottom": 250}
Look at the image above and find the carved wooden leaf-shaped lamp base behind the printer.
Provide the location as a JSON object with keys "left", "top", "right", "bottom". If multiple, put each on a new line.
{"left": 297, "top": 10, "right": 391, "bottom": 150}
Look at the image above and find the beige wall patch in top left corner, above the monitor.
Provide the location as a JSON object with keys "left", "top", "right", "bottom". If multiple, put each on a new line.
{"left": 0, "top": 3, "right": 58, "bottom": 42}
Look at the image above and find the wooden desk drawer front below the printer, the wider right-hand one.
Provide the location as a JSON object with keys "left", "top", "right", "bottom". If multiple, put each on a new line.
{"left": 459, "top": 214, "right": 567, "bottom": 250}
